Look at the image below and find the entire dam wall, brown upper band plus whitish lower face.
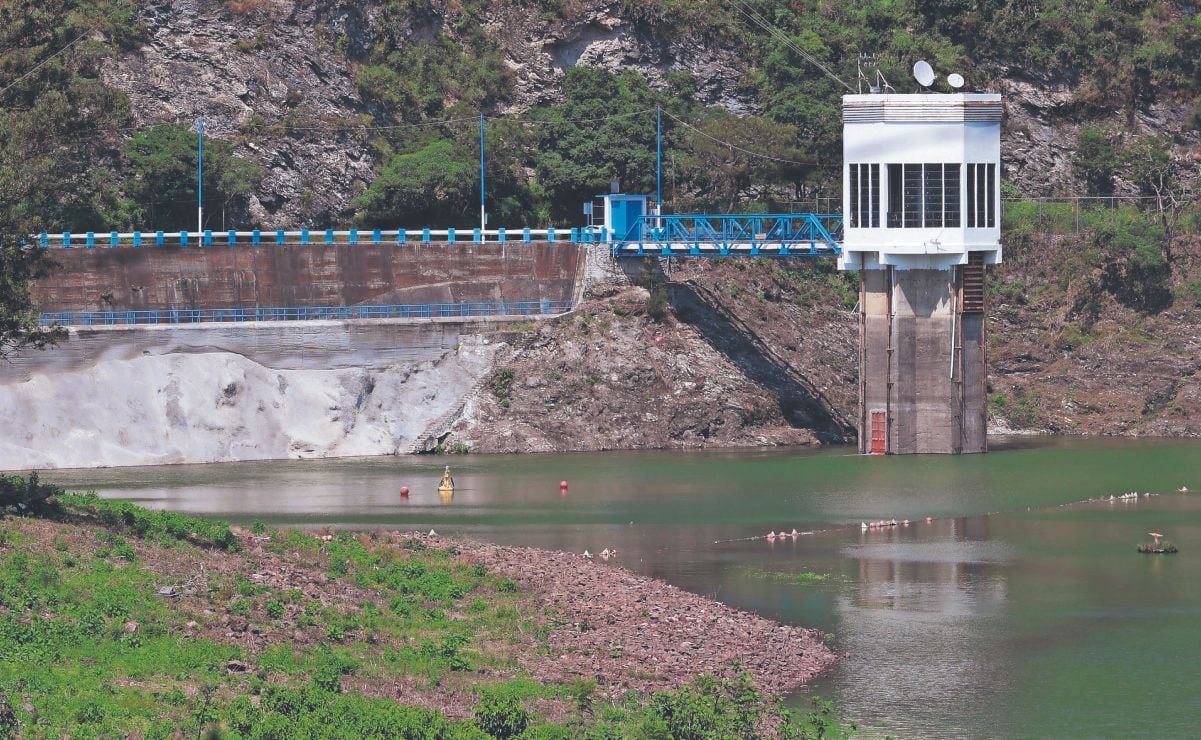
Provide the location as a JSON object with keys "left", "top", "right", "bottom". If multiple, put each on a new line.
{"left": 0, "top": 244, "right": 584, "bottom": 471}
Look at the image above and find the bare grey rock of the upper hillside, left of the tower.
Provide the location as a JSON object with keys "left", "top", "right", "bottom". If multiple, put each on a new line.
{"left": 102, "top": 0, "right": 754, "bottom": 227}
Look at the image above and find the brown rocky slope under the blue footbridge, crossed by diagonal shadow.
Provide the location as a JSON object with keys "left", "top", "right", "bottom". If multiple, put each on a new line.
{"left": 448, "top": 261, "right": 858, "bottom": 452}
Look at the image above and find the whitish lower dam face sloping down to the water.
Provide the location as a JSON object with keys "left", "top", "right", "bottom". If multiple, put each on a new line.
{"left": 0, "top": 322, "right": 498, "bottom": 470}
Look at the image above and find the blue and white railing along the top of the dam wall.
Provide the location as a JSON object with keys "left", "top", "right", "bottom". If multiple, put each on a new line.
{"left": 36, "top": 226, "right": 608, "bottom": 249}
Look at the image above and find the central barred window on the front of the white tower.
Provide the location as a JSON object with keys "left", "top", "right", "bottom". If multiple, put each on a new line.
{"left": 888, "top": 163, "right": 960, "bottom": 228}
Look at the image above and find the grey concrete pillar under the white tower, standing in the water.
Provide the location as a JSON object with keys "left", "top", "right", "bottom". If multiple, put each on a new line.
{"left": 859, "top": 267, "right": 987, "bottom": 454}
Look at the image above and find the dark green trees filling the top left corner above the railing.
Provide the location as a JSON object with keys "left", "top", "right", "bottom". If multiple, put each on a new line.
{"left": 0, "top": 0, "right": 142, "bottom": 233}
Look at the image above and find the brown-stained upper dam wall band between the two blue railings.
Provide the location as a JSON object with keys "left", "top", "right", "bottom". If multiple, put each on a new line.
{"left": 34, "top": 242, "right": 582, "bottom": 311}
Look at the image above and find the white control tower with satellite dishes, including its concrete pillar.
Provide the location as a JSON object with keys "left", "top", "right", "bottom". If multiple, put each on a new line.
{"left": 838, "top": 82, "right": 1002, "bottom": 454}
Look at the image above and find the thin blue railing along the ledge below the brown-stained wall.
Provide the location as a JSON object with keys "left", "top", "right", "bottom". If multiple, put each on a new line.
{"left": 41, "top": 300, "right": 572, "bottom": 327}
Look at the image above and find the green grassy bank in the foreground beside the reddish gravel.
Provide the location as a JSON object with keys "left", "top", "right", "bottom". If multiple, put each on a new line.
{"left": 0, "top": 478, "right": 854, "bottom": 739}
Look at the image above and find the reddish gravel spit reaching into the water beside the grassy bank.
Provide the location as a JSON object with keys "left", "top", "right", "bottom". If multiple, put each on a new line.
{"left": 413, "top": 533, "right": 835, "bottom": 697}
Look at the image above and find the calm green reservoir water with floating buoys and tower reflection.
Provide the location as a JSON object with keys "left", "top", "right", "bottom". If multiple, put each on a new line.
{"left": 43, "top": 438, "right": 1201, "bottom": 738}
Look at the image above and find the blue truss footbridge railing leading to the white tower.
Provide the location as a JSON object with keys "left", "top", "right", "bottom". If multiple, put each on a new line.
{"left": 613, "top": 214, "right": 842, "bottom": 257}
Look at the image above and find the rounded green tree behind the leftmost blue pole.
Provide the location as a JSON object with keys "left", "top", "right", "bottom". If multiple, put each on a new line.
{"left": 123, "top": 124, "right": 263, "bottom": 229}
